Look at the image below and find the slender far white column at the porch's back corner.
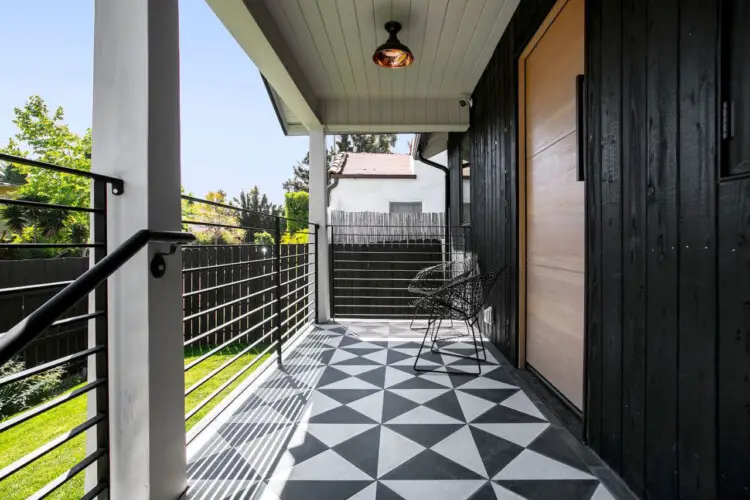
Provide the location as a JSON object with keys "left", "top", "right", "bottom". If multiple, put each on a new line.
{"left": 310, "top": 130, "right": 331, "bottom": 323}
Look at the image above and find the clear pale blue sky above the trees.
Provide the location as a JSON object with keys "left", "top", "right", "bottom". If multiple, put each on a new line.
{"left": 0, "top": 0, "right": 407, "bottom": 203}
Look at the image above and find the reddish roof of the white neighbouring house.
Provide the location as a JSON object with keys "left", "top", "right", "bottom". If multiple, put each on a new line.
{"left": 328, "top": 153, "right": 417, "bottom": 179}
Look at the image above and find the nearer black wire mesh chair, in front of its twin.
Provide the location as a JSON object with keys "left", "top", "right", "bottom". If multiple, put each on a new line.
{"left": 414, "top": 266, "right": 508, "bottom": 375}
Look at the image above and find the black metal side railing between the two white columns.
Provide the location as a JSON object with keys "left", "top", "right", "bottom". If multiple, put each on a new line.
{"left": 182, "top": 196, "right": 319, "bottom": 439}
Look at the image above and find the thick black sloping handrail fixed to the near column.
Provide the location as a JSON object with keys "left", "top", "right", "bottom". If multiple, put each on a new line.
{"left": 0, "top": 229, "right": 195, "bottom": 366}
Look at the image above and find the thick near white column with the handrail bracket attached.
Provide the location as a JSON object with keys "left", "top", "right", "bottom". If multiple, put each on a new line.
{"left": 92, "top": 0, "right": 187, "bottom": 500}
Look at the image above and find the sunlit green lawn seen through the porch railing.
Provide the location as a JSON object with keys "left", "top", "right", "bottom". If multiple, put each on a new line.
{"left": 0, "top": 345, "right": 269, "bottom": 500}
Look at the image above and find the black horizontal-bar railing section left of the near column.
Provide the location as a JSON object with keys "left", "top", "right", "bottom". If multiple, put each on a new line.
{"left": 0, "top": 153, "right": 124, "bottom": 498}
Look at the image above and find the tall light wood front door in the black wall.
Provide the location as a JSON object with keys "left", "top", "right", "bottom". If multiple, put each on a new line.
{"left": 522, "top": 0, "right": 585, "bottom": 409}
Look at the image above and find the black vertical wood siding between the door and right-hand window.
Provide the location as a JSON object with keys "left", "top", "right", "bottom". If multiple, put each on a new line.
{"left": 587, "top": 0, "right": 728, "bottom": 499}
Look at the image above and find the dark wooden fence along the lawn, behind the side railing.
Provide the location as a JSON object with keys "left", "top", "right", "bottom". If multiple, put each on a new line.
{"left": 0, "top": 244, "right": 313, "bottom": 369}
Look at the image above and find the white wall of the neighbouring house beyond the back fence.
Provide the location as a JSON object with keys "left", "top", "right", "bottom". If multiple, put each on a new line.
{"left": 330, "top": 152, "right": 447, "bottom": 212}
